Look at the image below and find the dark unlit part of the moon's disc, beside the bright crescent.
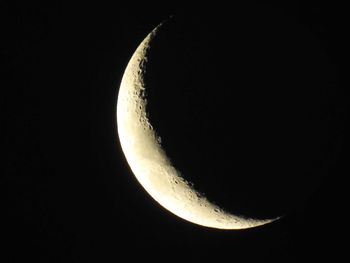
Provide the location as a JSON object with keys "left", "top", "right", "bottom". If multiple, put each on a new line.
{"left": 145, "top": 13, "right": 335, "bottom": 222}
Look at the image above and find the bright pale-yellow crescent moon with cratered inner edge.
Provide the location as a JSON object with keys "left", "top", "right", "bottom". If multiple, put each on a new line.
{"left": 117, "top": 24, "right": 278, "bottom": 229}
